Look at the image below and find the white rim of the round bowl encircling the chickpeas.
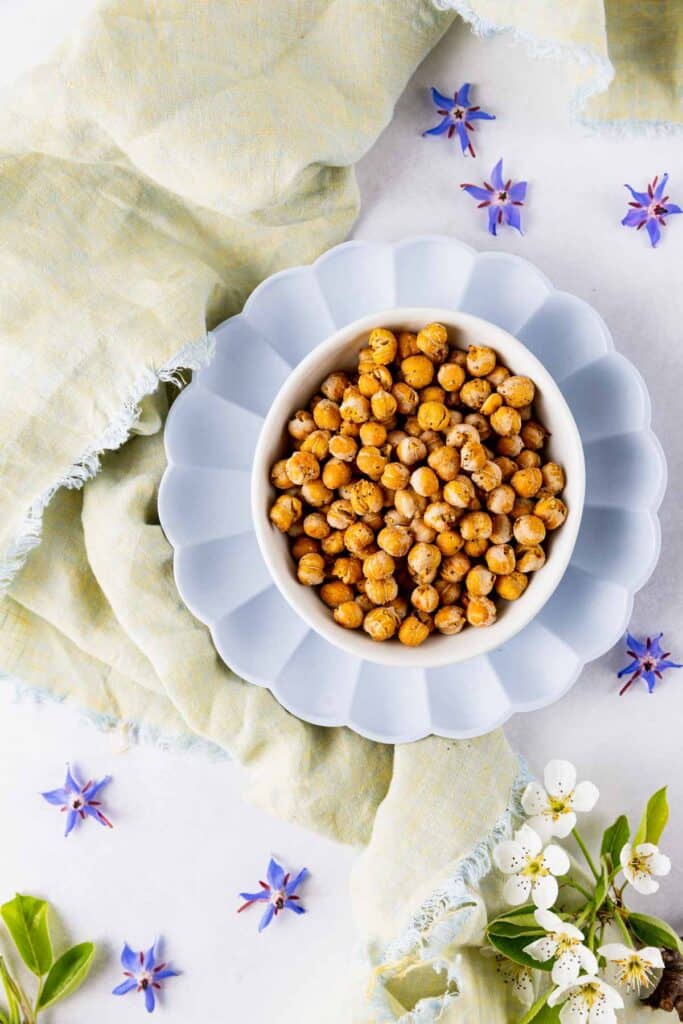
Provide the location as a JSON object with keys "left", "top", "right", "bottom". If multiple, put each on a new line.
{"left": 250, "top": 306, "right": 586, "bottom": 669}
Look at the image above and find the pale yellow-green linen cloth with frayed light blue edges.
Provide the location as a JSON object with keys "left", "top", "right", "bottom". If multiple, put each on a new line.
{"left": 0, "top": 0, "right": 680, "bottom": 1024}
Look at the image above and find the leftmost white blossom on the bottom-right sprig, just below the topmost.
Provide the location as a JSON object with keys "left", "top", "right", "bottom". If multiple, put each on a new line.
{"left": 494, "top": 825, "right": 569, "bottom": 909}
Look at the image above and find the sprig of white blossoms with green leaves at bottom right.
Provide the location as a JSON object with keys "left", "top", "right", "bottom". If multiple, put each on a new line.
{"left": 486, "top": 761, "right": 681, "bottom": 1024}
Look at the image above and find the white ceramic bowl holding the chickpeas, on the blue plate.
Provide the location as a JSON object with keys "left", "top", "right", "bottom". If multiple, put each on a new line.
{"left": 251, "top": 306, "right": 586, "bottom": 668}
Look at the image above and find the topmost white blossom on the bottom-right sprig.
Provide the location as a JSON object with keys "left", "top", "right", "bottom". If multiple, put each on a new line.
{"left": 522, "top": 761, "right": 599, "bottom": 842}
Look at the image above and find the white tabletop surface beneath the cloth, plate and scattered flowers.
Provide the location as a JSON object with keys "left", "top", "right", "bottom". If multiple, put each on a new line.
{"left": 0, "top": 0, "right": 683, "bottom": 1024}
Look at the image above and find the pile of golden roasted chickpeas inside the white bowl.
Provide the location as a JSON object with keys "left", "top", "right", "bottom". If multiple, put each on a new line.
{"left": 269, "top": 324, "right": 567, "bottom": 647}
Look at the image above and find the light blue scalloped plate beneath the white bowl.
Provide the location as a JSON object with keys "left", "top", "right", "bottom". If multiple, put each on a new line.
{"left": 159, "top": 236, "right": 667, "bottom": 742}
